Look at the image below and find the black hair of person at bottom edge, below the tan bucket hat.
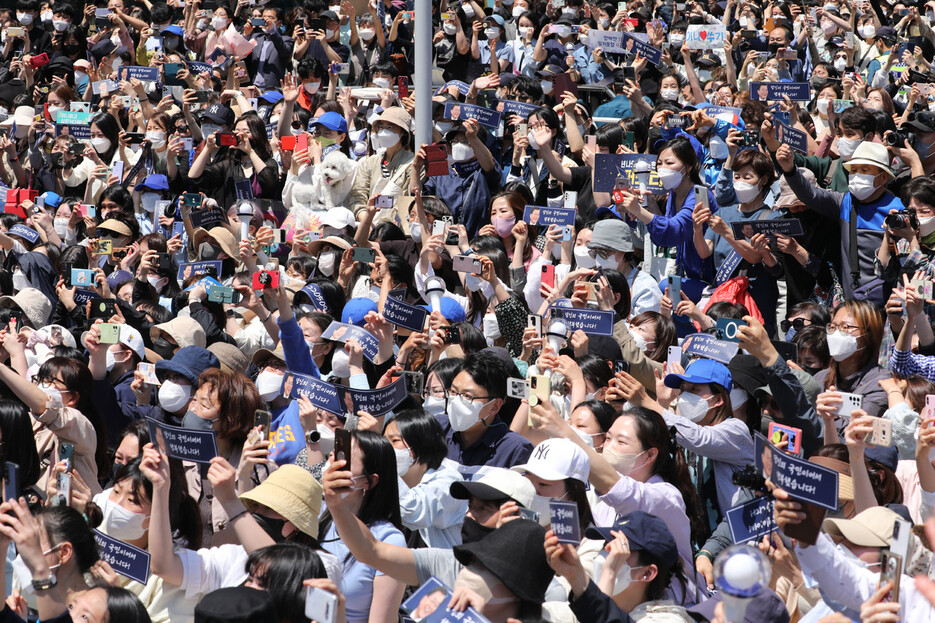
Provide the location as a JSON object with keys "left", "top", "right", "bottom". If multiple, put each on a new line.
{"left": 245, "top": 543, "right": 328, "bottom": 623}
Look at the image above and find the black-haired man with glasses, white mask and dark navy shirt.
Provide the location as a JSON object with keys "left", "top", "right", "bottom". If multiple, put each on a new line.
{"left": 438, "top": 348, "right": 532, "bottom": 480}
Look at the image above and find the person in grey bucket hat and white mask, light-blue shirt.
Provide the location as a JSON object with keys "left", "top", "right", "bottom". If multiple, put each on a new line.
{"left": 587, "top": 218, "right": 662, "bottom": 315}
